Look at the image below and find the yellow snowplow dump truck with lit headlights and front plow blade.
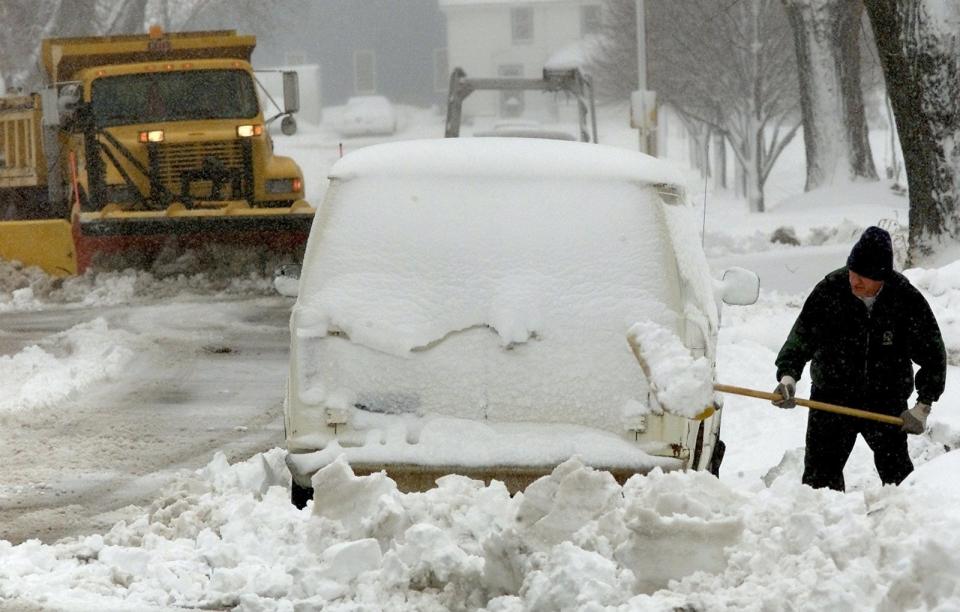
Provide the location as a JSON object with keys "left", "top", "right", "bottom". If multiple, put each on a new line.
{"left": 0, "top": 28, "right": 315, "bottom": 276}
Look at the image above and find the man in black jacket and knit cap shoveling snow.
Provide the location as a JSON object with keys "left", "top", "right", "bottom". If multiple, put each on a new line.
{"left": 773, "top": 227, "right": 946, "bottom": 491}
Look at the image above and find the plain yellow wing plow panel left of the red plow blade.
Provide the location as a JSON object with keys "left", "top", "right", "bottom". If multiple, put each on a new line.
{"left": 0, "top": 219, "right": 78, "bottom": 276}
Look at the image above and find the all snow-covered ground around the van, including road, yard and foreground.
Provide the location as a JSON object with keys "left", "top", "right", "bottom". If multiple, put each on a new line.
{"left": 0, "top": 108, "right": 960, "bottom": 612}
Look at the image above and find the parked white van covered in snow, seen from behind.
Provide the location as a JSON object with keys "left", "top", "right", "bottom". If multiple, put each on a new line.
{"left": 284, "top": 138, "right": 756, "bottom": 505}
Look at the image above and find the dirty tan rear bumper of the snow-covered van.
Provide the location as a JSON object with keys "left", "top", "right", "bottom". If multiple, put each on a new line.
{"left": 286, "top": 453, "right": 684, "bottom": 495}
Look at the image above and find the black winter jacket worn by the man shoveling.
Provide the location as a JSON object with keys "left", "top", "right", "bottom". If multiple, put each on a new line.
{"left": 777, "top": 267, "right": 947, "bottom": 407}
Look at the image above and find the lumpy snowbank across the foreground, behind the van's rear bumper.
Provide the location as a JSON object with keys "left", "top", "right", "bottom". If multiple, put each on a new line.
{"left": 0, "top": 449, "right": 960, "bottom": 612}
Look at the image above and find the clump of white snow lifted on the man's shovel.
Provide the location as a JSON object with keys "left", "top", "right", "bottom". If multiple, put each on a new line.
{"left": 627, "top": 321, "right": 713, "bottom": 418}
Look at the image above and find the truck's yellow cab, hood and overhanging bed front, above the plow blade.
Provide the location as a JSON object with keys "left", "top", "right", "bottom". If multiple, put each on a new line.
{"left": 43, "top": 30, "right": 303, "bottom": 212}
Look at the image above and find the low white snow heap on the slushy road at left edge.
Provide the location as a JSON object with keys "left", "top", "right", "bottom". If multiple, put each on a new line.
{"left": 0, "top": 318, "right": 137, "bottom": 415}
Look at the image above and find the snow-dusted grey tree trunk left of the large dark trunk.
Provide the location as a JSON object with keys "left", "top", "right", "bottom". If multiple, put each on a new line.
{"left": 783, "top": 0, "right": 877, "bottom": 191}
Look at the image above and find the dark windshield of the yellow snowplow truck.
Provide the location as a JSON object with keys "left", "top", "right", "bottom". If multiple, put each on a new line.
{"left": 92, "top": 70, "right": 259, "bottom": 127}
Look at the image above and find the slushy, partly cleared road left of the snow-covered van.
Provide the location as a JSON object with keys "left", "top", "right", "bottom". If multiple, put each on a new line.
{"left": 0, "top": 297, "right": 290, "bottom": 543}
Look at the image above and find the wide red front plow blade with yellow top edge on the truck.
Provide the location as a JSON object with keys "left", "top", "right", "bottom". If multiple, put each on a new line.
{"left": 74, "top": 200, "right": 315, "bottom": 273}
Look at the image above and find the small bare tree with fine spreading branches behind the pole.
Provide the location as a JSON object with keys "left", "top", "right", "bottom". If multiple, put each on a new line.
{"left": 590, "top": 0, "right": 800, "bottom": 211}
